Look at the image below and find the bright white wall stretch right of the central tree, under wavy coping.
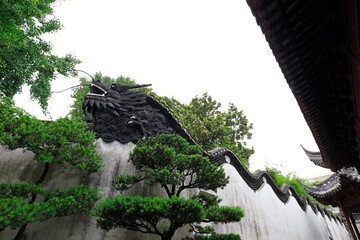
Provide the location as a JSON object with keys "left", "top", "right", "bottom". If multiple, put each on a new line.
{"left": 215, "top": 164, "right": 350, "bottom": 240}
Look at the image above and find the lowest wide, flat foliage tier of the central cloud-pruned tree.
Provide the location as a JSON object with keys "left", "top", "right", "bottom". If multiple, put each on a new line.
{"left": 93, "top": 196, "right": 205, "bottom": 232}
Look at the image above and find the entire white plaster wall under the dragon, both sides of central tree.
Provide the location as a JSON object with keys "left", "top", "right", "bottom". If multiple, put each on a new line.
{"left": 0, "top": 140, "right": 350, "bottom": 240}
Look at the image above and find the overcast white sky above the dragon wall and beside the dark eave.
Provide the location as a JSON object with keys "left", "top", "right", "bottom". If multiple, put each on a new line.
{"left": 15, "top": 0, "right": 332, "bottom": 177}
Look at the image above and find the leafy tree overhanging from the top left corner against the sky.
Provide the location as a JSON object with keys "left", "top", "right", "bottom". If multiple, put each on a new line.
{"left": 0, "top": 0, "right": 79, "bottom": 110}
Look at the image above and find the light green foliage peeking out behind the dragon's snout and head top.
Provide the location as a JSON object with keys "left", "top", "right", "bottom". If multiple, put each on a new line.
{"left": 69, "top": 72, "right": 136, "bottom": 122}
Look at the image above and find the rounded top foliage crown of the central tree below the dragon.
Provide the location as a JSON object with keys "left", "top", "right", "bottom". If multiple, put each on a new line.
{"left": 119, "top": 134, "right": 229, "bottom": 197}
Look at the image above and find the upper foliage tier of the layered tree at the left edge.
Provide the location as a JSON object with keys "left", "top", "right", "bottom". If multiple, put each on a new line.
{"left": 0, "top": 98, "right": 101, "bottom": 172}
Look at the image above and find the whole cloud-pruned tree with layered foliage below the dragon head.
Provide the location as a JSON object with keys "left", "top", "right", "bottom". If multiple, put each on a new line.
{"left": 92, "top": 134, "right": 243, "bottom": 240}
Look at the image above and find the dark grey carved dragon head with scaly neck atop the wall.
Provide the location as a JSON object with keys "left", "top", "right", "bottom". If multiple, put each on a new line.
{"left": 83, "top": 81, "right": 174, "bottom": 143}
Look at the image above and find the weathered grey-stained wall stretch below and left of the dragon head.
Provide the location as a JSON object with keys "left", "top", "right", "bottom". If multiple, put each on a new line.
{"left": 0, "top": 140, "right": 191, "bottom": 240}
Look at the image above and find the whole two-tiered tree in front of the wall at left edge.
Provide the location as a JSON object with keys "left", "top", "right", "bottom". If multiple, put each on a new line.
{"left": 0, "top": 98, "right": 101, "bottom": 239}
